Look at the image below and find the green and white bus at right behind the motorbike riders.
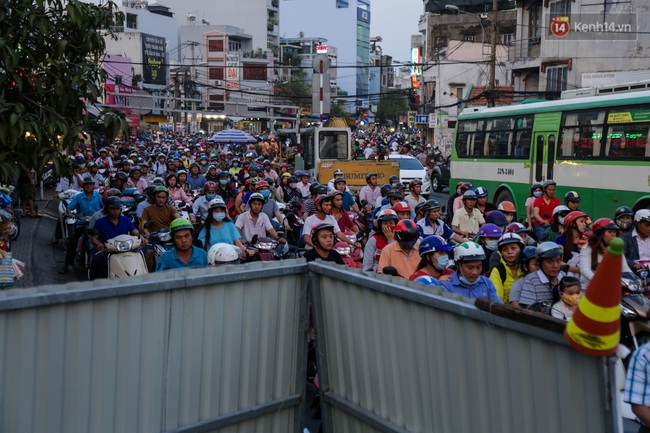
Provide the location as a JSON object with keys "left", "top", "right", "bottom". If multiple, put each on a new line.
{"left": 450, "top": 91, "right": 650, "bottom": 219}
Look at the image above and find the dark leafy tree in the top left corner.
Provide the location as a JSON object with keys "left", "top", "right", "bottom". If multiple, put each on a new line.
{"left": 0, "top": 0, "right": 126, "bottom": 181}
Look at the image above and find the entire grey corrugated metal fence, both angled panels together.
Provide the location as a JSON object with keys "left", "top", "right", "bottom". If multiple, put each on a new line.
{"left": 0, "top": 261, "right": 617, "bottom": 433}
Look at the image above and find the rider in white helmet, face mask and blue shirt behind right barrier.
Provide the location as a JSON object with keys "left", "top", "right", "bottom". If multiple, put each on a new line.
{"left": 442, "top": 242, "right": 502, "bottom": 304}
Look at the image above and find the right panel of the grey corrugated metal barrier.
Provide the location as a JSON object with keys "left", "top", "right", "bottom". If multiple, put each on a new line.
{"left": 309, "top": 263, "right": 619, "bottom": 433}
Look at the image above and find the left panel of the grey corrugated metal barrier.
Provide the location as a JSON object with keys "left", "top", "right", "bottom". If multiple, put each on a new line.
{"left": 0, "top": 261, "right": 307, "bottom": 433}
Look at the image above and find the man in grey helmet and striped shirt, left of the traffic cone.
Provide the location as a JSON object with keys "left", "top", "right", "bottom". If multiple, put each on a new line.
{"left": 518, "top": 242, "right": 566, "bottom": 308}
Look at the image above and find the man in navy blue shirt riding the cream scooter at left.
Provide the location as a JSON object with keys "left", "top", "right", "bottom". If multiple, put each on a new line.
{"left": 89, "top": 196, "right": 147, "bottom": 280}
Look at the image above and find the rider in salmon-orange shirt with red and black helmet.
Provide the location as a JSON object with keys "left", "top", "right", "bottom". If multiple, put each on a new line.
{"left": 377, "top": 219, "right": 420, "bottom": 278}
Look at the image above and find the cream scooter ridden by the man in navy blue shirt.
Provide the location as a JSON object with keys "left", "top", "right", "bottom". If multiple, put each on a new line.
{"left": 105, "top": 235, "right": 148, "bottom": 280}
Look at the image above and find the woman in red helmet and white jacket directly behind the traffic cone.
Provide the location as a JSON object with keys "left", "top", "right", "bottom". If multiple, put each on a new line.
{"left": 580, "top": 218, "right": 631, "bottom": 290}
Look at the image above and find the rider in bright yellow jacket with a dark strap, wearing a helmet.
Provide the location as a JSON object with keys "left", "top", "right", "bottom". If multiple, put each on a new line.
{"left": 483, "top": 233, "right": 524, "bottom": 303}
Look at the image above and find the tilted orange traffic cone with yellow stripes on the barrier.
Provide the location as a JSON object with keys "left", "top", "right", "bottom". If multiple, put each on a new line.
{"left": 564, "top": 238, "right": 623, "bottom": 356}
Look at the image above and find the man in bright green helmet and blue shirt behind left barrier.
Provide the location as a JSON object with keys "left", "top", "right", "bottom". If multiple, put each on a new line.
{"left": 156, "top": 218, "right": 208, "bottom": 272}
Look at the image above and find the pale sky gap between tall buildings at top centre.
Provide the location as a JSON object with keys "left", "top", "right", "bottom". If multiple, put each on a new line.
{"left": 370, "top": 0, "right": 424, "bottom": 62}
